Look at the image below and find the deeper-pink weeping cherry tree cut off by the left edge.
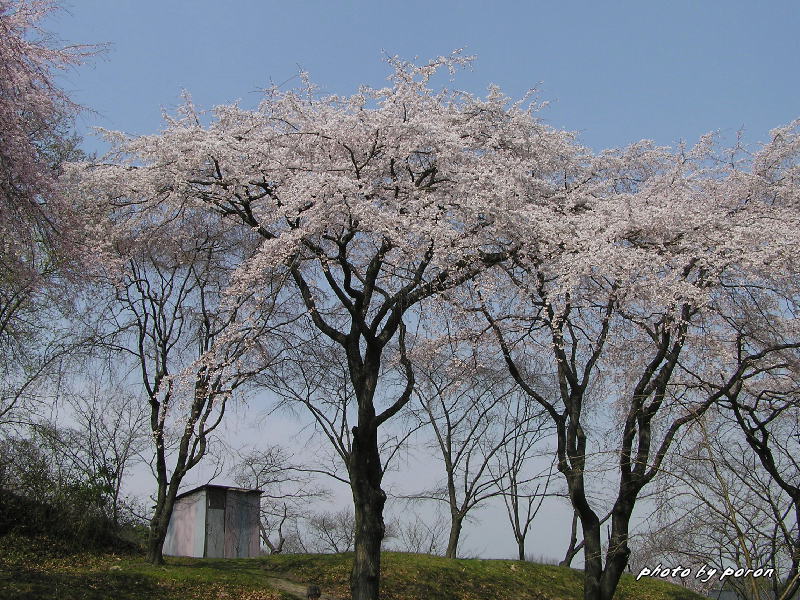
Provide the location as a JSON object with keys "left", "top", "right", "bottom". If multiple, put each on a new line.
{"left": 0, "top": 0, "right": 98, "bottom": 432}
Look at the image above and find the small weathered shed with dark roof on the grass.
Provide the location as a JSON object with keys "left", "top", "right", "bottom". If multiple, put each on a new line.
{"left": 164, "top": 484, "right": 262, "bottom": 558}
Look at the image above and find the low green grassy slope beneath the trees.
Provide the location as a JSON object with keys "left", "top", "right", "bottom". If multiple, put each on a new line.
{"left": 0, "top": 534, "right": 701, "bottom": 600}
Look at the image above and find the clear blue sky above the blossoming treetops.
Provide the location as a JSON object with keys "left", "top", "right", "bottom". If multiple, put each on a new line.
{"left": 47, "top": 0, "right": 800, "bottom": 156}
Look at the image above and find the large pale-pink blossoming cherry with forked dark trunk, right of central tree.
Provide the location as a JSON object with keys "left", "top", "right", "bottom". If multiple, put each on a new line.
{"left": 472, "top": 123, "right": 800, "bottom": 600}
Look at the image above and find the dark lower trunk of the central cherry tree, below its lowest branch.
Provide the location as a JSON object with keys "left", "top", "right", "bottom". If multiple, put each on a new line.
{"left": 350, "top": 427, "right": 386, "bottom": 600}
